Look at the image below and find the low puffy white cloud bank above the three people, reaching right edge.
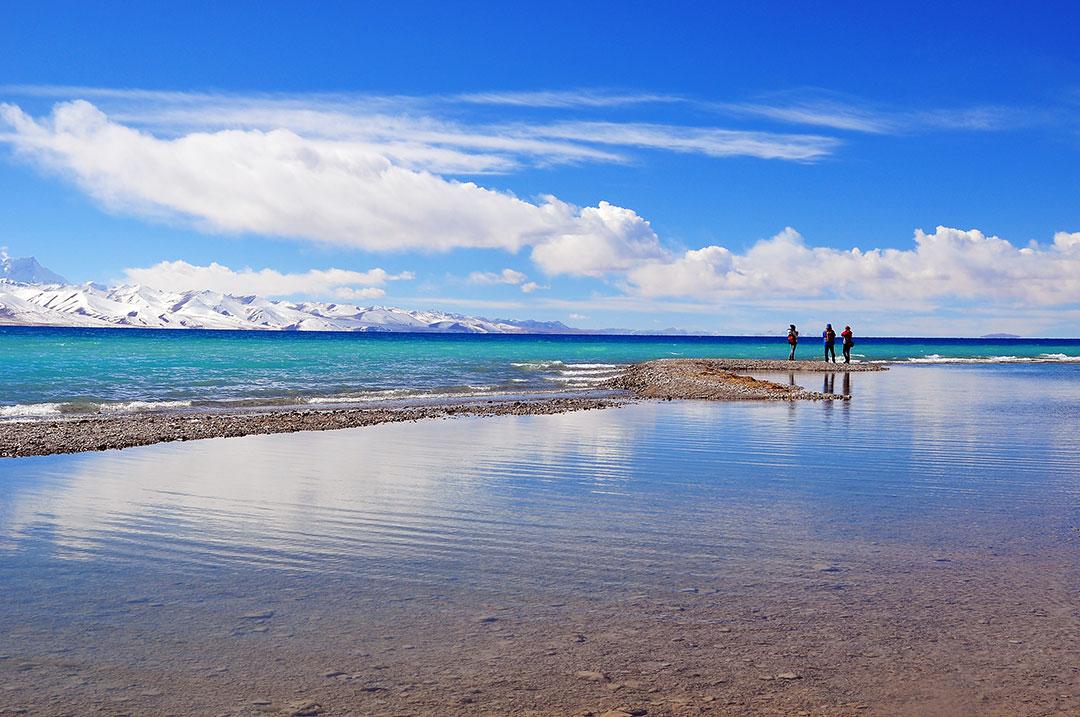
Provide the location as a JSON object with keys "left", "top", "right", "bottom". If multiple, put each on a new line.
{"left": 626, "top": 227, "right": 1080, "bottom": 307}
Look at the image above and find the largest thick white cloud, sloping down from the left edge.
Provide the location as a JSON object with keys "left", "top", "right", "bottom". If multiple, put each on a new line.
{"left": 0, "top": 102, "right": 673, "bottom": 258}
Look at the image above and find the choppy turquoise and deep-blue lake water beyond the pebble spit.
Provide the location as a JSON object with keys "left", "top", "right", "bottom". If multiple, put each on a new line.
{"left": 0, "top": 327, "right": 1080, "bottom": 417}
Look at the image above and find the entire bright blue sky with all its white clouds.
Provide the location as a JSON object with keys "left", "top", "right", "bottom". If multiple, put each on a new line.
{"left": 0, "top": 1, "right": 1080, "bottom": 336}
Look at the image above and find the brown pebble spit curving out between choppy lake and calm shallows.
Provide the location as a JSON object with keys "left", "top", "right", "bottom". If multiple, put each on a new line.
{"left": 0, "top": 359, "right": 887, "bottom": 458}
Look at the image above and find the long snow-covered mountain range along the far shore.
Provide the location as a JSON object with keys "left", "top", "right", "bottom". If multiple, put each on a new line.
{"left": 0, "top": 269, "right": 557, "bottom": 334}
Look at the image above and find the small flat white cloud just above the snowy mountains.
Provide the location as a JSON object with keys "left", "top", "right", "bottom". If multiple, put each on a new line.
{"left": 124, "top": 260, "right": 414, "bottom": 299}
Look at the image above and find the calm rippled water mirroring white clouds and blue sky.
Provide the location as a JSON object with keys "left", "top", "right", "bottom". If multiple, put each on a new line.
{"left": 0, "top": 366, "right": 1080, "bottom": 590}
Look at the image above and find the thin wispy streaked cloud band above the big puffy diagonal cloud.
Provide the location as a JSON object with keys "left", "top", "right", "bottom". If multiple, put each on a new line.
{"left": 0, "top": 85, "right": 839, "bottom": 174}
